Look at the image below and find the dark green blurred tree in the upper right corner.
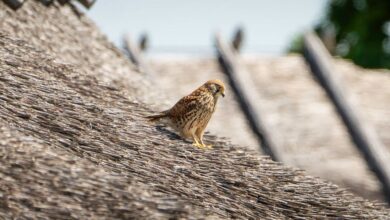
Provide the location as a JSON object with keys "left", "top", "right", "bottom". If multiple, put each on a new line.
{"left": 289, "top": 0, "right": 390, "bottom": 69}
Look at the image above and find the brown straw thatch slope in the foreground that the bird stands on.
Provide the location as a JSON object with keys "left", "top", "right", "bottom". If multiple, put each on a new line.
{"left": 0, "top": 32, "right": 389, "bottom": 219}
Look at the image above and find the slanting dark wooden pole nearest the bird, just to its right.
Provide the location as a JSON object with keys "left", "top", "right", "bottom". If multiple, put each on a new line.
{"left": 215, "top": 35, "right": 281, "bottom": 161}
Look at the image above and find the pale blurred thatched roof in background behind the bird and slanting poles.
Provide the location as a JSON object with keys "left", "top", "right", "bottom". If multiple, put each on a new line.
{"left": 149, "top": 56, "right": 390, "bottom": 200}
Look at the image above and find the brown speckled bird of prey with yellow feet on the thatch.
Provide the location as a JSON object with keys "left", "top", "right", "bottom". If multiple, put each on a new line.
{"left": 146, "top": 80, "right": 225, "bottom": 148}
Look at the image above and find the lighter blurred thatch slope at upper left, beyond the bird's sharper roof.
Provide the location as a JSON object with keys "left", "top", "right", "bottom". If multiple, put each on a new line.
{"left": 0, "top": 0, "right": 157, "bottom": 102}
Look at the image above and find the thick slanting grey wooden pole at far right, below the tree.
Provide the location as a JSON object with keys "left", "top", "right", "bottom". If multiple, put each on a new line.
{"left": 304, "top": 32, "right": 390, "bottom": 203}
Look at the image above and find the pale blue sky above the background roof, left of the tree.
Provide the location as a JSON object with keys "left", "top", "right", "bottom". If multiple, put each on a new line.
{"left": 87, "top": 0, "right": 327, "bottom": 55}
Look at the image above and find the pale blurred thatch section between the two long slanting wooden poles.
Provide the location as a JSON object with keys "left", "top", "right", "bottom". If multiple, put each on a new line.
{"left": 241, "top": 56, "right": 382, "bottom": 199}
